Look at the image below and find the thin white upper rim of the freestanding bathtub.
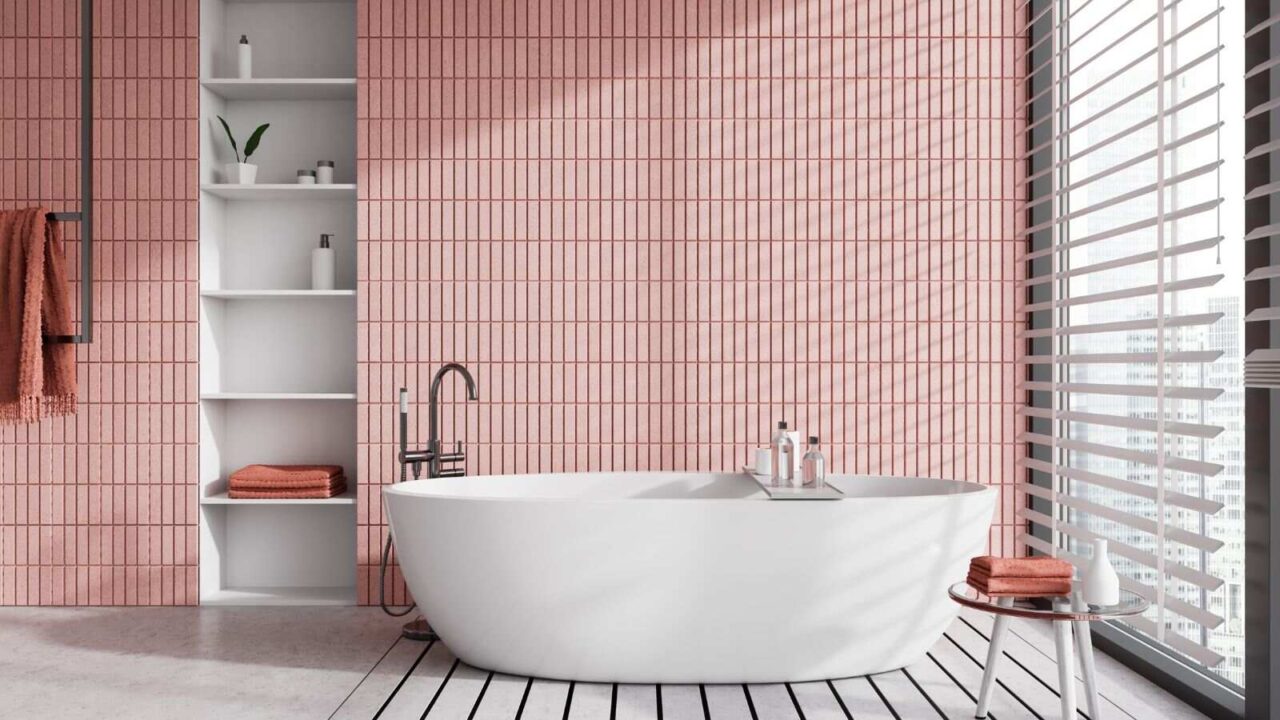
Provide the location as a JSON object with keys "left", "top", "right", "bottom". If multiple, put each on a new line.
{"left": 380, "top": 470, "right": 996, "bottom": 506}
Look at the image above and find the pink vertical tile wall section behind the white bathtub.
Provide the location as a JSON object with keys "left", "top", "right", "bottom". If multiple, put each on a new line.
{"left": 358, "top": 0, "right": 1021, "bottom": 602}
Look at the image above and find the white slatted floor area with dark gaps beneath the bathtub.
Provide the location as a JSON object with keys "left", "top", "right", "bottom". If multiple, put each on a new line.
{"left": 332, "top": 611, "right": 1203, "bottom": 720}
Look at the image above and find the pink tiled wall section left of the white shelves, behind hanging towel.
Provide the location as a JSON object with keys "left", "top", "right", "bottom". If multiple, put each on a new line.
{"left": 0, "top": 0, "right": 198, "bottom": 605}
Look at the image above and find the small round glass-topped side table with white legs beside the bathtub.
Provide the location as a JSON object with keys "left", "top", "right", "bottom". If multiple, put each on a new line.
{"left": 947, "top": 583, "right": 1151, "bottom": 720}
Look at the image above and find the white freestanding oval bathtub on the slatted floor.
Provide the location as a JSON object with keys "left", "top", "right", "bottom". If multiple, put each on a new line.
{"left": 383, "top": 473, "right": 995, "bottom": 683}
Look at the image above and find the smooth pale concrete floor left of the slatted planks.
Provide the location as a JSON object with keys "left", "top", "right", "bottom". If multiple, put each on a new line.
{"left": 0, "top": 607, "right": 402, "bottom": 720}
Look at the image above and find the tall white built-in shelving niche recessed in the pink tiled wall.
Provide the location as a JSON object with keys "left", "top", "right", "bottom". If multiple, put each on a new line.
{"left": 200, "top": 0, "right": 360, "bottom": 605}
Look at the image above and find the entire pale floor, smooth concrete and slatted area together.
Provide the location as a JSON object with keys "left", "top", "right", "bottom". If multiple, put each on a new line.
{"left": 0, "top": 607, "right": 1203, "bottom": 720}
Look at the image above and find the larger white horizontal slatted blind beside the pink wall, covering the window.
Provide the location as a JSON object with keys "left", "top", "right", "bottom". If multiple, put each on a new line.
{"left": 1019, "top": 0, "right": 1239, "bottom": 666}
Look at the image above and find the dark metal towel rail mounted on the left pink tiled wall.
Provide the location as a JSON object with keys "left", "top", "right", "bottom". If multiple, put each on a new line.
{"left": 45, "top": 0, "right": 93, "bottom": 345}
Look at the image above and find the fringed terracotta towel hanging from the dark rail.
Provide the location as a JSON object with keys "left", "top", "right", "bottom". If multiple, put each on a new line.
{"left": 0, "top": 208, "right": 76, "bottom": 424}
